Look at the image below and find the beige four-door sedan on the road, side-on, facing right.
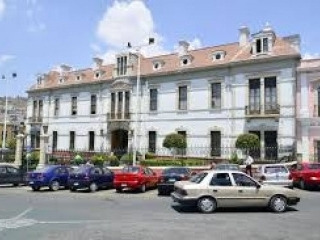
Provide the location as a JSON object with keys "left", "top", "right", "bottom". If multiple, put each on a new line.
{"left": 171, "top": 170, "right": 300, "bottom": 213}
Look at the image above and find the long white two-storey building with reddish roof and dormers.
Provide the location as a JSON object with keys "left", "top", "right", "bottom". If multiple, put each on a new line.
{"left": 27, "top": 26, "right": 300, "bottom": 161}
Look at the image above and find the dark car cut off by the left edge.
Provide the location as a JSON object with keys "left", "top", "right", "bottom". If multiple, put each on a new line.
{"left": 0, "top": 164, "right": 26, "bottom": 186}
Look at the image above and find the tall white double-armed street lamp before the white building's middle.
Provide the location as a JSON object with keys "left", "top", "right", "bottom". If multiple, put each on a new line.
{"left": 127, "top": 38, "right": 154, "bottom": 166}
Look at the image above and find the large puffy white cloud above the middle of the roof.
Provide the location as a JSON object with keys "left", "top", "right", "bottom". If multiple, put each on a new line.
{"left": 95, "top": 0, "right": 168, "bottom": 63}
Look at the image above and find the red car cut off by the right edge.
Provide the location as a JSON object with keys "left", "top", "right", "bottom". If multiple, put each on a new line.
{"left": 291, "top": 163, "right": 320, "bottom": 189}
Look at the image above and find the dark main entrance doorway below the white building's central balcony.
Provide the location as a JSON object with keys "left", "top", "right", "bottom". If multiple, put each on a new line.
{"left": 111, "top": 129, "right": 128, "bottom": 155}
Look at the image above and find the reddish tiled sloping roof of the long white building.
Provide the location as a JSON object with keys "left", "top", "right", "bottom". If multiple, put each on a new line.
{"left": 28, "top": 37, "right": 300, "bottom": 92}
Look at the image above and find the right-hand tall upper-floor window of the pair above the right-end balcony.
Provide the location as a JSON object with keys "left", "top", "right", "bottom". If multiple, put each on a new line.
{"left": 264, "top": 77, "right": 278, "bottom": 113}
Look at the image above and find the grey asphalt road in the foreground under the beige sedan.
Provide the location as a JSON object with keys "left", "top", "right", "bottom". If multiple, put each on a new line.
{"left": 0, "top": 187, "right": 320, "bottom": 240}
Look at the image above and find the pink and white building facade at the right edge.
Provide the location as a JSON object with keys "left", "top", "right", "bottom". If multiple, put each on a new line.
{"left": 297, "top": 59, "right": 320, "bottom": 162}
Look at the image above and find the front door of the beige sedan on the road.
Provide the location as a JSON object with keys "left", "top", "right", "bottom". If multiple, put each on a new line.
{"left": 232, "top": 172, "right": 268, "bottom": 207}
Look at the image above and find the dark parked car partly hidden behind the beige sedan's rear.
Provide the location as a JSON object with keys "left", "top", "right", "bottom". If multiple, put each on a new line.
{"left": 158, "top": 167, "right": 191, "bottom": 195}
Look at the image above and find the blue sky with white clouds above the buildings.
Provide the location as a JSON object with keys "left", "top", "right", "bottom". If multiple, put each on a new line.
{"left": 0, "top": 0, "right": 320, "bottom": 96}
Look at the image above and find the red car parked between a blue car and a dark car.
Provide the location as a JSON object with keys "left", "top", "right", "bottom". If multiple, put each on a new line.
{"left": 113, "top": 166, "right": 159, "bottom": 192}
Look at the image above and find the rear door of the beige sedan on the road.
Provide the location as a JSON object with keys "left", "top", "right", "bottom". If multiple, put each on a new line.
{"left": 208, "top": 172, "right": 236, "bottom": 207}
